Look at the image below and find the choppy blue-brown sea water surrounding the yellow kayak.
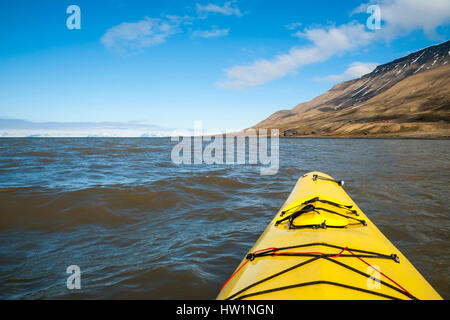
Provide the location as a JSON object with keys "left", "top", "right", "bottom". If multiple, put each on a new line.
{"left": 0, "top": 138, "right": 450, "bottom": 299}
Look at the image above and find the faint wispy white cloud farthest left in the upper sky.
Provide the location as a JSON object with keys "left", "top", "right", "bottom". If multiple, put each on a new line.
{"left": 100, "top": 16, "right": 182, "bottom": 53}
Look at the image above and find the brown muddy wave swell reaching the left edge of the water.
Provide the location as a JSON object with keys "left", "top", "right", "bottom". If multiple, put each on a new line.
{"left": 0, "top": 187, "right": 181, "bottom": 231}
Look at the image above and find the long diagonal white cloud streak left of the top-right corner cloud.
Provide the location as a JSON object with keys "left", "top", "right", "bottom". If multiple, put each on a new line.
{"left": 216, "top": 22, "right": 374, "bottom": 89}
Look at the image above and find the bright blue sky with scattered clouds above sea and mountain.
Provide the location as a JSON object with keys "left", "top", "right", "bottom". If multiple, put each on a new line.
{"left": 0, "top": 0, "right": 450, "bottom": 129}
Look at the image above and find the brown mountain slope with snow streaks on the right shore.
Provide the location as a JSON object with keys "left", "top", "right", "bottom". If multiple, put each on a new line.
{"left": 253, "top": 41, "right": 450, "bottom": 138}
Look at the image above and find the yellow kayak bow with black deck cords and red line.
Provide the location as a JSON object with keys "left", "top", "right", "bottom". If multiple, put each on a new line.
{"left": 217, "top": 172, "right": 442, "bottom": 300}
